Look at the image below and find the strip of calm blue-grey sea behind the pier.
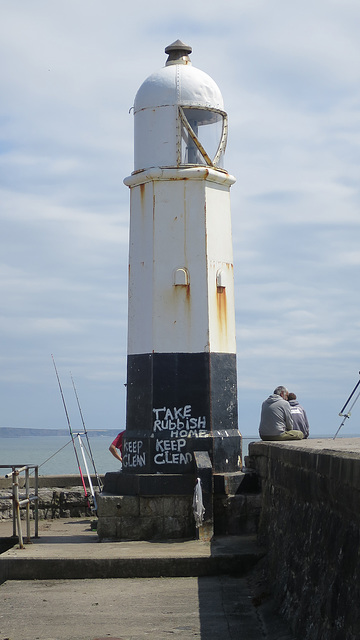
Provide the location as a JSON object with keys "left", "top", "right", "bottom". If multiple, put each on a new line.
{"left": 0, "top": 434, "right": 359, "bottom": 476}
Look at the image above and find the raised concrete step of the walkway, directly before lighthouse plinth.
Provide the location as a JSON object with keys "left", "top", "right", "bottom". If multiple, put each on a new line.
{"left": 0, "top": 519, "right": 263, "bottom": 581}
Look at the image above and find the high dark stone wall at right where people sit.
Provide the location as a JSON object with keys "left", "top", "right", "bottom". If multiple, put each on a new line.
{"left": 246, "top": 439, "right": 360, "bottom": 640}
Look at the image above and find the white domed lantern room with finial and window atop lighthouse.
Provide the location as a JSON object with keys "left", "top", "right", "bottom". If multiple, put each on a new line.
{"left": 134, "top": 40, "right": 227, "bottom": 171}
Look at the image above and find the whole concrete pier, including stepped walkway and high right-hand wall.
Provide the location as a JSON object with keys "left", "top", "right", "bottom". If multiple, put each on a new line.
{"left": 0, "top": 438, "right": 360, "bottom": 640}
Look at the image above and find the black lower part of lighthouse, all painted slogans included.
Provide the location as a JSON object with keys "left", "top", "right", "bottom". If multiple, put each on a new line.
{"left": 123, "top": 353, "right": 241, "bottom": 474}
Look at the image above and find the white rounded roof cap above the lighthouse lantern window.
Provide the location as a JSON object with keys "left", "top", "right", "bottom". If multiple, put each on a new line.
{"left": 134, "top": 41, "right": 224, "bottom": 113}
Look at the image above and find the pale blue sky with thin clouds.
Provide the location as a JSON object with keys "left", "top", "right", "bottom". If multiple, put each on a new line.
{"left": 0, "top": 0, "right": 360, "bottom": 435}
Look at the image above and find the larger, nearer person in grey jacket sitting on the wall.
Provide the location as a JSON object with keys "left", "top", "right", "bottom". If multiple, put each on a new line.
{"left": 259, "top": 386, "right": 304, "bottom": 440}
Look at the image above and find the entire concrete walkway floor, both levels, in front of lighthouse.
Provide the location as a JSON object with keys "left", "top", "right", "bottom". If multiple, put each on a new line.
{"left": 0, "top": 519, "right": 293, "bottom": 640}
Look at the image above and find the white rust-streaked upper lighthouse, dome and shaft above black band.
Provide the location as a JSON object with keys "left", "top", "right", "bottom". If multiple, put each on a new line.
{"left": 124, "top": 47, "right": 236, "bottom": 355}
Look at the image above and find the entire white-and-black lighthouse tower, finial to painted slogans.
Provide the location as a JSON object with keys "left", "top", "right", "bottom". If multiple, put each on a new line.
{"left": 123, "top": 40, "right": 241, "bottom": 474}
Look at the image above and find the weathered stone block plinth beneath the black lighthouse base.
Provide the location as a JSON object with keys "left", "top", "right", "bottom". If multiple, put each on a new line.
{"left": 97, "top": 470, "right": 260, "bottom": 541}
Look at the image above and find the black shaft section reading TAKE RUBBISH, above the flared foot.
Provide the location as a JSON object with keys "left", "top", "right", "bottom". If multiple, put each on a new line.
{"left": 126, "top": 352, "right": 238, "bottom": 433}
